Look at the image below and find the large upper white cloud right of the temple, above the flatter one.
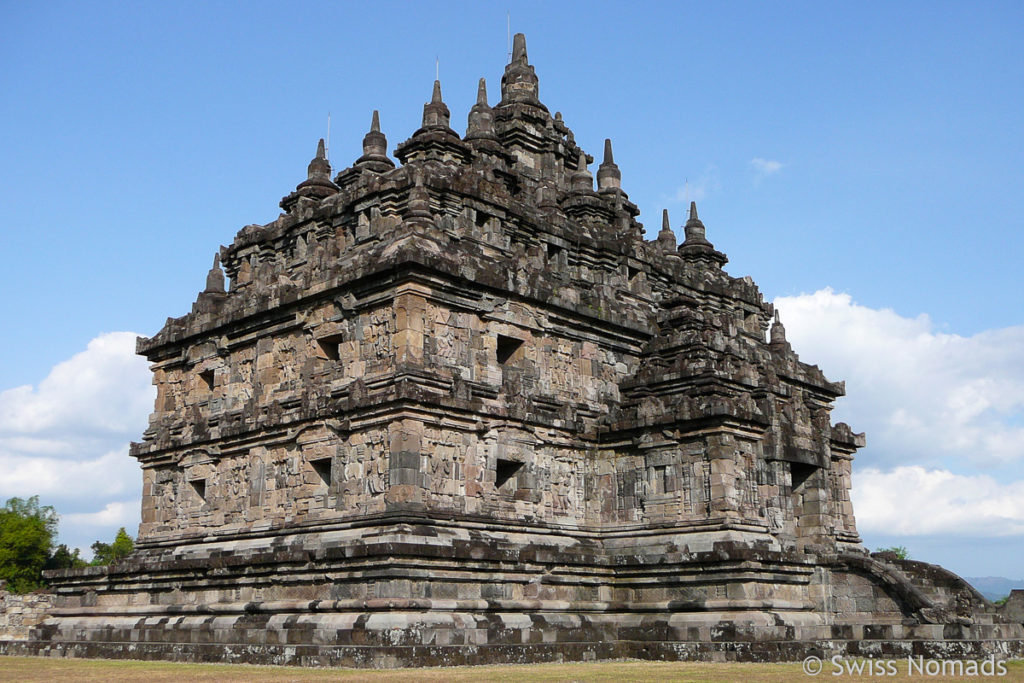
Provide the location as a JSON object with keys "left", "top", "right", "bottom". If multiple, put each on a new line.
{"left": 775, "top": 289, "right": 1024, "bottom": 469}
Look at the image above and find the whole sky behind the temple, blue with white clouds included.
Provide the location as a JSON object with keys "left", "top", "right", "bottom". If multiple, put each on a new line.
{"left": 0, "top": 2, "right": 1024, "bottom": 579}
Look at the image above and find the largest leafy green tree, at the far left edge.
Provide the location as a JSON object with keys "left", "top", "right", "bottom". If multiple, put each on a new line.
{"left": 0, "top": 496, "right": 59, "bottom": 593}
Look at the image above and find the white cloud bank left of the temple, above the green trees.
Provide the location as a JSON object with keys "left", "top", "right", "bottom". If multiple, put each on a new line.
{"left": 0, "top": 332, "right": 156, "bottom": 552}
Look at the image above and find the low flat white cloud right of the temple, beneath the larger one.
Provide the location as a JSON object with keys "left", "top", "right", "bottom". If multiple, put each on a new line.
{"left": 851, "top": 466, "right": 1024, "bottom": 537}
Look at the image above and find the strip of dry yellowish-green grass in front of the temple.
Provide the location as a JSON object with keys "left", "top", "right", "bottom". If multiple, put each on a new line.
{"left": 0, "top": 656, "right": 1024, "bottom": 683}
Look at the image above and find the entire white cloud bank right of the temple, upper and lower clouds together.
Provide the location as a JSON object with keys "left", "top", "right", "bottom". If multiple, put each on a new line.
{"left": 774, "top": 289, "right": 1024, "bottom": 537}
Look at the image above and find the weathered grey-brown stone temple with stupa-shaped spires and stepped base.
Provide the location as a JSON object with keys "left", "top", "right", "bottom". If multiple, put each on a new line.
{"left": 9, "top": 35, "right": 1024, "bottom": 666}
